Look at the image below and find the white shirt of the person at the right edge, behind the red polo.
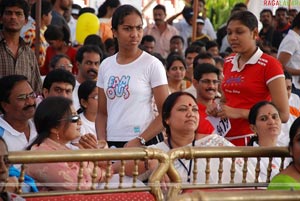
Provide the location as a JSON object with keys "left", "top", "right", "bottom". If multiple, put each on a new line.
{"left": 277, "top": 29, "right": 300, "bottom": 89}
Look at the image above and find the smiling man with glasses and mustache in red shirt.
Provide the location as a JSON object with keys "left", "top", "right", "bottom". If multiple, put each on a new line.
{"left": 193, "top": 63, "right": 220, "bottom": 134}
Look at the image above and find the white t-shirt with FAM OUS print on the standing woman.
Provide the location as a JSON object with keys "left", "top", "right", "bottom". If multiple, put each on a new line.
{"left": 97, "top": 51, "right": 168, "bottom": 141}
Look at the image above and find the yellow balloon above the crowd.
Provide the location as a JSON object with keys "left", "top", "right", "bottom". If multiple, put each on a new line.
{"left": 76, "top": 13, "right": 99, "bottom": 44}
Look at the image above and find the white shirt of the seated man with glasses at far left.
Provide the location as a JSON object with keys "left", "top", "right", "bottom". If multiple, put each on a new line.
{"left": 0, "top": 116, "right": 37, "bottom": 151}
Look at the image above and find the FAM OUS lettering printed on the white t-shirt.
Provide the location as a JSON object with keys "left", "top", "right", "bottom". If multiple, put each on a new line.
{"left": 106, "top": 75, "right": 130, "bottom": 99}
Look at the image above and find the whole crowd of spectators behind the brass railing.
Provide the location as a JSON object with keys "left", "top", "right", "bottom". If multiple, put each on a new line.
{"left": 0, "top": 0, "right": 300, "bottom": 196}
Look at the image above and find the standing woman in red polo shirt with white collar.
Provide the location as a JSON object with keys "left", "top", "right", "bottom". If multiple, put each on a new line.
{"left": 207, "top": 11, "right": 289, "bottom": 146}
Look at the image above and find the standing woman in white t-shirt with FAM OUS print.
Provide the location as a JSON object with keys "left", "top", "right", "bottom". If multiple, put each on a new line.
{"left": 96, "top": 5, "right": 168, "bottom": 147}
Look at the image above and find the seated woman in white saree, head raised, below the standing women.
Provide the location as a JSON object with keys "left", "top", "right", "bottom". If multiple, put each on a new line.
{"left": 126, "top": 92, "right": 255, "bottom": 183}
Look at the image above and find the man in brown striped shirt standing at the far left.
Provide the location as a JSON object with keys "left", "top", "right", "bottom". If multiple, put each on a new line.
{"left": 0, "top": 0, "right": 42, "bottom": 94}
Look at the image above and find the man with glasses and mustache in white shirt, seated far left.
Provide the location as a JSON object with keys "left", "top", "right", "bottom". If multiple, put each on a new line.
{"left": 0, "top": 75, "right": 37, "bottom": 151}
